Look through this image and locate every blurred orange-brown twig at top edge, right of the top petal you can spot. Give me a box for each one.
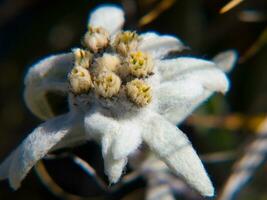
[138,0,176,26]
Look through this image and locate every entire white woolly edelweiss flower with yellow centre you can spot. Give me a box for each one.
[0,6,239,196]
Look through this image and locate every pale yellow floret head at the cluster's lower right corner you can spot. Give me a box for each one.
[126,79,152,107]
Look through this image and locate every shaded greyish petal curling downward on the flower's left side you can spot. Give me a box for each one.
[24,53,74,119]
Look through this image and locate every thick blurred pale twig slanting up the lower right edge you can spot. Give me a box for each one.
[219,118,267,200]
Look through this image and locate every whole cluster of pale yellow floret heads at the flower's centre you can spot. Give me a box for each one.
[68,27,153,107]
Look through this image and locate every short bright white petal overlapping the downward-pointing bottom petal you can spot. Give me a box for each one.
[112,121,142,159]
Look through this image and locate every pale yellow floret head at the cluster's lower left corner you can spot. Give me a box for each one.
[68,66,93,94]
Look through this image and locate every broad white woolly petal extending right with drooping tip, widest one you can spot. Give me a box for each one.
[155,58,229,124]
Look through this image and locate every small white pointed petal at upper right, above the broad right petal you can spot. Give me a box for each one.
[139,32,185,59]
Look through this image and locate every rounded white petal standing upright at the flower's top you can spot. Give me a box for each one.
[88,5,124,35]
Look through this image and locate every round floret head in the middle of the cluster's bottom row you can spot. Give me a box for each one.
[94,71,121,98]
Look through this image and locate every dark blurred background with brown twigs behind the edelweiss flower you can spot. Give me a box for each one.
[0,0,267,200]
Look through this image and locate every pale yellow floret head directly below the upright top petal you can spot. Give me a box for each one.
[83,27,109,53]
